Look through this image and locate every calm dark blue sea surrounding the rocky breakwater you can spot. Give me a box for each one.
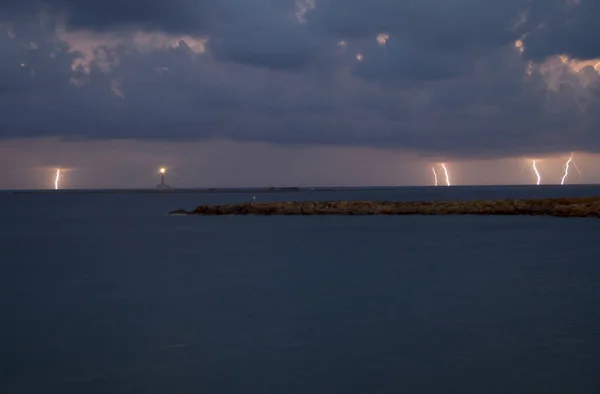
[0,185,600,394]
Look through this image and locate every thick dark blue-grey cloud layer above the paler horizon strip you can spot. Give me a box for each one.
[0,0,600,158]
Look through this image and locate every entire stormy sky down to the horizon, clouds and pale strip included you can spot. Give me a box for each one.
[0,0,600,188]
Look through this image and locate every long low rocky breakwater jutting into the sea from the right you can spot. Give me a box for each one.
[170,197,600,218]
